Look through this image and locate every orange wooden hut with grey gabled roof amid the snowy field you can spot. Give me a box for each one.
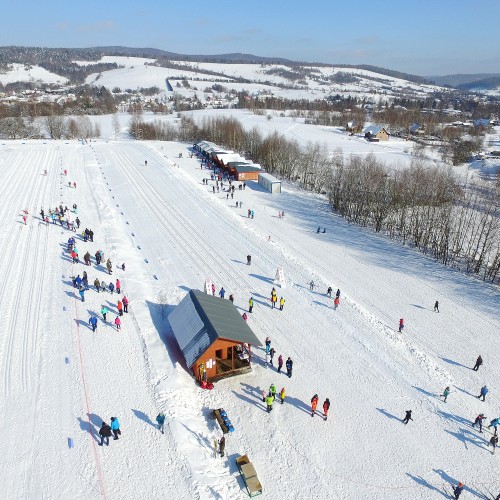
[168,290,262,385]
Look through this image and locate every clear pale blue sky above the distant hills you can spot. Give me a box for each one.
[0,0,500,75]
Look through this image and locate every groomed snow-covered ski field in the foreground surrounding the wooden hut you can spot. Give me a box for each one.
[0,138,500,500]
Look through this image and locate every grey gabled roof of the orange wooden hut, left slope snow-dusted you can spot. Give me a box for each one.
[168,290,262,368]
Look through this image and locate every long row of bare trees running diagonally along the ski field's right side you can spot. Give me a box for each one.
[130,116,500,282]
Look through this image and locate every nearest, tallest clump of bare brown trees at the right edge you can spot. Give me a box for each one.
[328,154,500,282]
